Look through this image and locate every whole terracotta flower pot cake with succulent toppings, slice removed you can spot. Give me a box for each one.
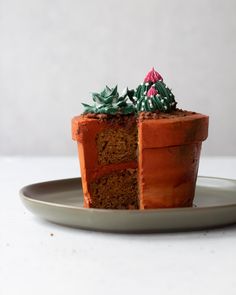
[72,69,208,209]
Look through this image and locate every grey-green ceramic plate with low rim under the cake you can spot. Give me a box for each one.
[20,177,236,232]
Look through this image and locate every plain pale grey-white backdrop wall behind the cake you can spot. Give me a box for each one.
[0,0,236,155]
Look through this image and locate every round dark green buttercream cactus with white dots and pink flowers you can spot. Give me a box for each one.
[134,68,177,113]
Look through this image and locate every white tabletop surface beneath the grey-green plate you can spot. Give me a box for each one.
[0,157,236,295]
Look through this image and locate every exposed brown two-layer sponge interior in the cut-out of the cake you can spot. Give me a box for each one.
[82,114,138,209]
